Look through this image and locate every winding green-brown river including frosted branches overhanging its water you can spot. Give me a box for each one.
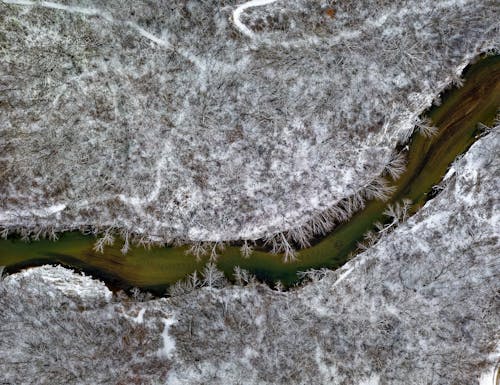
[0,56,500,294]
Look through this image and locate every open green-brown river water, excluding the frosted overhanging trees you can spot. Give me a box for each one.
[0,55,500,294]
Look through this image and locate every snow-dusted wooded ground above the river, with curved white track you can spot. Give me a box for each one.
[0,0,498,241]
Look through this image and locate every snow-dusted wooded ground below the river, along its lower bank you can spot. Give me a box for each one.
[0,127,500,385]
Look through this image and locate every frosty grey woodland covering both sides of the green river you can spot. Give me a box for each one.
[0,0,500,385]
